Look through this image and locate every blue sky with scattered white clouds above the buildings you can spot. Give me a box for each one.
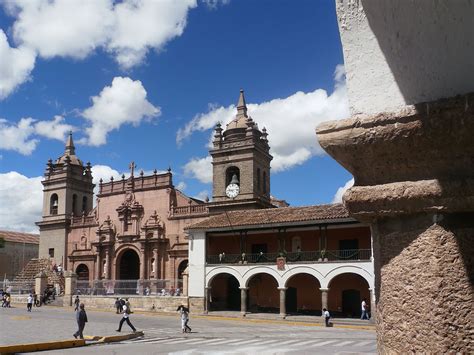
[0,0,353,232]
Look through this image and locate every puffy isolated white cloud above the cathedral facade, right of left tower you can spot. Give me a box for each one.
[82,77,160,146]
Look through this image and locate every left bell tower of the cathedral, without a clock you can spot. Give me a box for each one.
[36,132,95,268]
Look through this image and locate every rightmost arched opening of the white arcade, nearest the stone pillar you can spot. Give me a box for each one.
[328,273,370,318]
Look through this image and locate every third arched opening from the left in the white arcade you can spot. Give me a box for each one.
[285,273,322,315]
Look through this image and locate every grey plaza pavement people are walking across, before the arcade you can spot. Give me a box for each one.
[0,305,376,354]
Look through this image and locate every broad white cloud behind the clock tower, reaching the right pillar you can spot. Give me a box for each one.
[176,65,349,175]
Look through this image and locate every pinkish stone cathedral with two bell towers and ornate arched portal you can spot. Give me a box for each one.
[37,90,278,289]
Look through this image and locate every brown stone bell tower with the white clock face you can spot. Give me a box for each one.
[209,90,273,213]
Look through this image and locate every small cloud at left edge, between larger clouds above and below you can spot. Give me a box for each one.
[0,117,39,155]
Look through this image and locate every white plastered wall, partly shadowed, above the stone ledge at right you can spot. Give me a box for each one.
[336,0,474,114]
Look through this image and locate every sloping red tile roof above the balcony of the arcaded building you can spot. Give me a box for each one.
[185,203,355,230]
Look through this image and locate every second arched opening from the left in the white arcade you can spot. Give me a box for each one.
[247,273,280,313]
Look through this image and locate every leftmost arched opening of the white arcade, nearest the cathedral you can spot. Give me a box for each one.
[209,273,240,311]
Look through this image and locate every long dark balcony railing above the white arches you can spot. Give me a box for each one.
[206,249,372,265]
